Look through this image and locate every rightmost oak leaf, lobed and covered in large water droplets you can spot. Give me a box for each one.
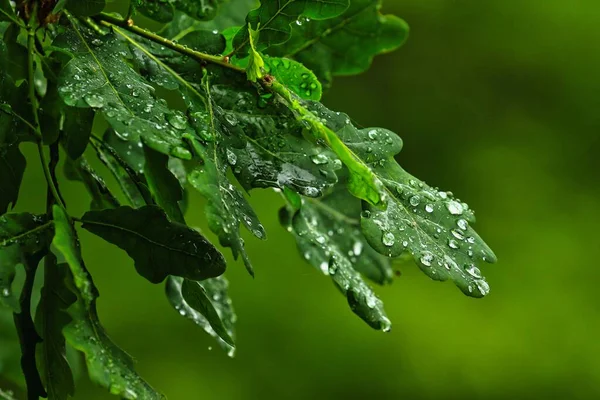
[310,103,496,297]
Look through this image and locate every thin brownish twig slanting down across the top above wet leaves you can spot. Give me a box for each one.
[96,13,246,73]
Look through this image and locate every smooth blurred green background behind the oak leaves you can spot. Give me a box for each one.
[0,0,600,400]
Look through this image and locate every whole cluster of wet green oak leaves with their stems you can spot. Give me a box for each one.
[0,0,495,399]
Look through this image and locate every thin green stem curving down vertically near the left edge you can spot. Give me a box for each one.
[27,22,65,208]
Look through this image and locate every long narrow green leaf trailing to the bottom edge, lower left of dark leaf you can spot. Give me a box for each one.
[52,206,164,400]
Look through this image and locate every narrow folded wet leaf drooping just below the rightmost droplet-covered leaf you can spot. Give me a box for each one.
[280,192,392,332]
